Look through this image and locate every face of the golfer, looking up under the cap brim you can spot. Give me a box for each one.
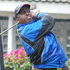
[16,8,32,24]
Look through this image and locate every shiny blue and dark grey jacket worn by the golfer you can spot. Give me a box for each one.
[17,13,67,68]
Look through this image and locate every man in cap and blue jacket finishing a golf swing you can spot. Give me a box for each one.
[15,4,67,70]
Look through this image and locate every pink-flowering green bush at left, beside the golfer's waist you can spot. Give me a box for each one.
[3,48,31,70]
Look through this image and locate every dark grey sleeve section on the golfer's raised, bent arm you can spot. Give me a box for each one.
[35,15,55,41]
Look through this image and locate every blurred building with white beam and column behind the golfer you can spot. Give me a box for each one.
[0,0,70,68]
